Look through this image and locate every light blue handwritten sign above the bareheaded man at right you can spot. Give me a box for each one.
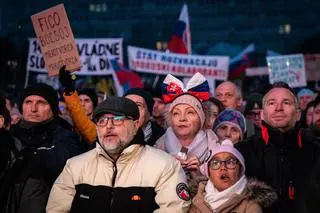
[267,54,307,87]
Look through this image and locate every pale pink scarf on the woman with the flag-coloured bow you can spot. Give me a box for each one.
[164,127,208,162]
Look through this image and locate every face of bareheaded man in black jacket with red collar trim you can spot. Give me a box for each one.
[262,88,301,132]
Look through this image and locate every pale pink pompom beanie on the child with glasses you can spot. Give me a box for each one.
[200,139,246,178]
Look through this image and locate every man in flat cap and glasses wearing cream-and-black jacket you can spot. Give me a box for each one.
[47,97,190,213]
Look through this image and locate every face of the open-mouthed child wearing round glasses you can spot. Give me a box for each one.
[208,152,241,192]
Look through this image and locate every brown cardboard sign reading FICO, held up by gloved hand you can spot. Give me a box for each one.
[31,4,81,76]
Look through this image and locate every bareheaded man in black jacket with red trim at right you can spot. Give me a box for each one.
[237,82,319,213]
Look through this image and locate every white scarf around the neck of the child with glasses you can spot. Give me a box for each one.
[204,175,248,211]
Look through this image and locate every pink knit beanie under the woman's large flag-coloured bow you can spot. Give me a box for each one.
[169,93,205,127]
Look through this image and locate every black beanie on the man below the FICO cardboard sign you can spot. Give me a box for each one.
[19,83,60,116]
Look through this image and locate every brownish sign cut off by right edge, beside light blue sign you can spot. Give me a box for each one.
[304,54,320,81]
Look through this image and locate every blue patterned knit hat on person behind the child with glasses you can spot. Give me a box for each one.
[212,108,247,140]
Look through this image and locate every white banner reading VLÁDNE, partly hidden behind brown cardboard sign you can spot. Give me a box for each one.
[27,38,123,75]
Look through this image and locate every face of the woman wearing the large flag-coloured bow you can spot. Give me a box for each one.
[170,104,201,139]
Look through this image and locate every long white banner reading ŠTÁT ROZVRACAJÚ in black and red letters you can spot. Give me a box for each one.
[128,46,229,80]
